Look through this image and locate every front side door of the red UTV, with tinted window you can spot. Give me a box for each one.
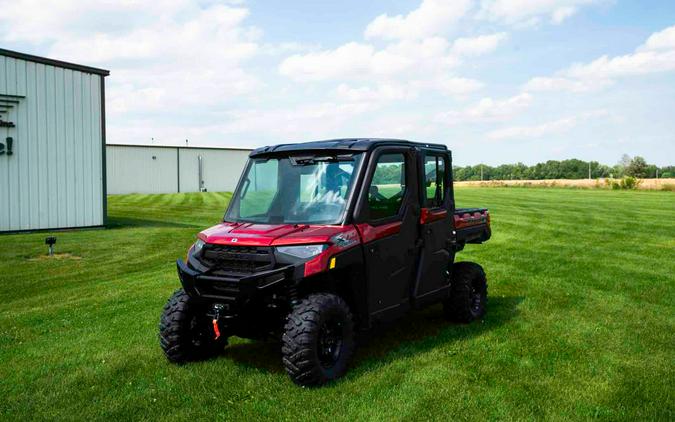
[355,147,419,320]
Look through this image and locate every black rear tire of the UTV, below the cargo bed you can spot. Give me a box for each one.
[443,262,487,323]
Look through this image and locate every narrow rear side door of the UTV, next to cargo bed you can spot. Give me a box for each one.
[412,150,453,305]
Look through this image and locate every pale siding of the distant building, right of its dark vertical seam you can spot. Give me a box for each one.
[180,148,250,192]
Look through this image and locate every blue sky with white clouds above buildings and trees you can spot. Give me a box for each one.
[0,0,675,166]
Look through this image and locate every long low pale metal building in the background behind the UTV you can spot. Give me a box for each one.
[106,144,251,194]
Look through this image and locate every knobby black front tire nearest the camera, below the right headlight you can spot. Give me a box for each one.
[281,293,354,386]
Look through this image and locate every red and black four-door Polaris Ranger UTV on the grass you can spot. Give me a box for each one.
[159,139,490,386]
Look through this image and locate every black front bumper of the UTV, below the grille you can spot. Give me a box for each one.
[176,259,297,303]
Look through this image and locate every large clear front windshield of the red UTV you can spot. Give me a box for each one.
[225,153,362,224]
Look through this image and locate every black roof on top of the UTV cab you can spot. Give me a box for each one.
[251,138,447,157]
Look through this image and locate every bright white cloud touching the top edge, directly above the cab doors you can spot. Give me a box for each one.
[365,0,472,40]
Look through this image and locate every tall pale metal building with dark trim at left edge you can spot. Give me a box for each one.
[0,49,109,232]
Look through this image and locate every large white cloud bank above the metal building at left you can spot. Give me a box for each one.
[0,0,262,119]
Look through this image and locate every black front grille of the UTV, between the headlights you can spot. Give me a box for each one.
[199,245,274,274]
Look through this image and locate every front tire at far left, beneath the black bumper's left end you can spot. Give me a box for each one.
[159,289,227,363]
